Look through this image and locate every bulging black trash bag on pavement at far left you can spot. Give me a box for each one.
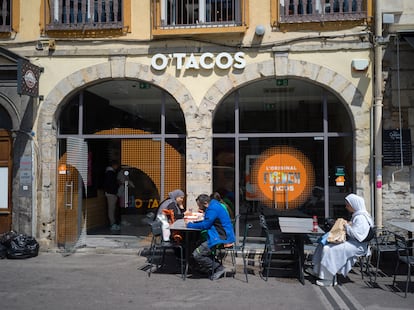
[7,234,39,259]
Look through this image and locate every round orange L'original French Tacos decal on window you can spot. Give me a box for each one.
[249,146,315,209]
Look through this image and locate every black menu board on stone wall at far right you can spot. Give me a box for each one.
[382,129,412,166]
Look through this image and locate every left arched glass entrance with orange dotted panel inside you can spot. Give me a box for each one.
[57,80,186,246]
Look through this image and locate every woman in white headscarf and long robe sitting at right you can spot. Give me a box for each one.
[306,194,374,286]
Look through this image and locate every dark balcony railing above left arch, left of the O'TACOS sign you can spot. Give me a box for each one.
[45,0,123,30]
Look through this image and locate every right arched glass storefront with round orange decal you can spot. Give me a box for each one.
[213,78,354,234]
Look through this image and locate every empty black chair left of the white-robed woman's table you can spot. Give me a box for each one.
[259,215,302,281]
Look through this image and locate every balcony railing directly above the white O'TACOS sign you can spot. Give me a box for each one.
[152,0,246,29]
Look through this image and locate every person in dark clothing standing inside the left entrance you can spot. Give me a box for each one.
[104,160,121,231]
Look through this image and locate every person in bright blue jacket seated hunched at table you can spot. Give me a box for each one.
[187,194,235,280]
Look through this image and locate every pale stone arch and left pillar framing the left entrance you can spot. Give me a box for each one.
[36,56,196,246]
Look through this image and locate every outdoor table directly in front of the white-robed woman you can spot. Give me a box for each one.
[279,217,325,284]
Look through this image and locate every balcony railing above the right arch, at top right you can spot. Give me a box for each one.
[275,0,367,23]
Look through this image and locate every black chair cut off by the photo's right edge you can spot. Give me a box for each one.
[392,234,414,297]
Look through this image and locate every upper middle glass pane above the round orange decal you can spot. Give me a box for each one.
[239,79,323,133]
